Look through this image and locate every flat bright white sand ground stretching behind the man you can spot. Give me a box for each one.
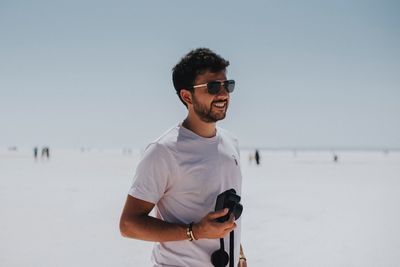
[0,149,400,267]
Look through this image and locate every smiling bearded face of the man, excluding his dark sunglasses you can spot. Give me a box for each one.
[192,71,229,122]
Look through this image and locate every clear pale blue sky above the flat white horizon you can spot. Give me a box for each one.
[0,0,400,149]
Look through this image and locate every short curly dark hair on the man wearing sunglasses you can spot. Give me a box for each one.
[172,48,229,106]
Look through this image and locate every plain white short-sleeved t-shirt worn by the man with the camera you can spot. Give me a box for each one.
[129,125,242,267]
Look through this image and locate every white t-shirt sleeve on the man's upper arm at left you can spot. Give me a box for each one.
[128,143,171,204]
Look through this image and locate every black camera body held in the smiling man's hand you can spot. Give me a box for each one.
[215,188,243,222]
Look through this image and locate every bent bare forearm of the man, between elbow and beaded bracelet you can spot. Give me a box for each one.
[120,215,187,242]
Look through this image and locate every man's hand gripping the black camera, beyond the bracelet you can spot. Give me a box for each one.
[192,209,236,239]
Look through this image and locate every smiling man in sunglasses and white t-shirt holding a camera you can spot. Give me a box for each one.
[120,48,246,267]
